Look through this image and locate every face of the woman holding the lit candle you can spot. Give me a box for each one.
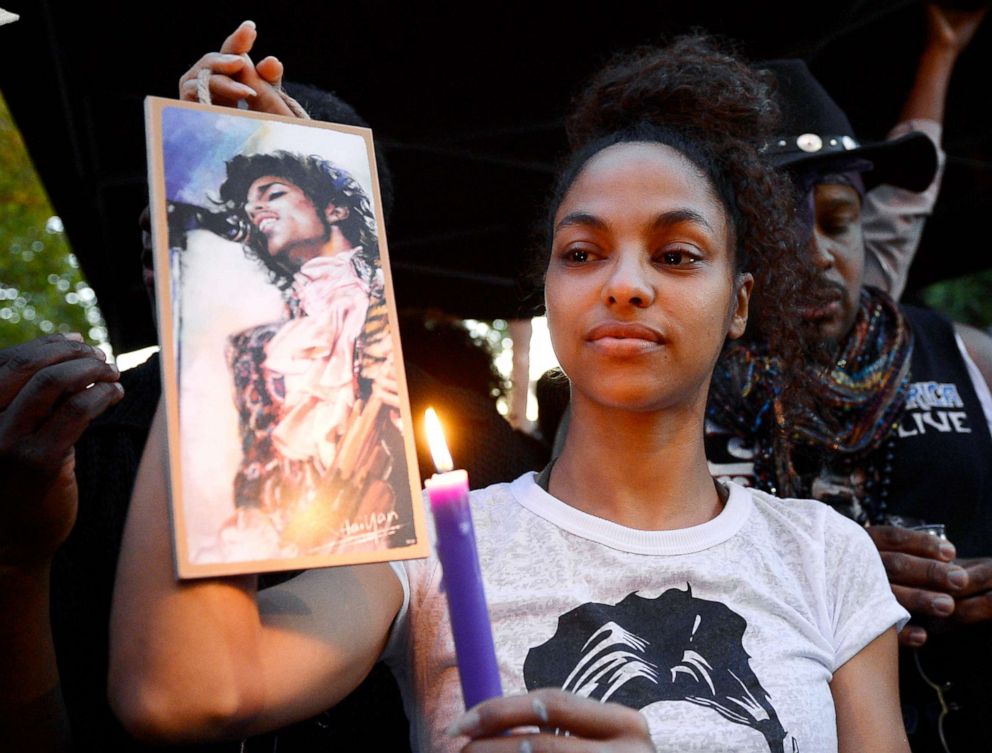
[545,143,751,410]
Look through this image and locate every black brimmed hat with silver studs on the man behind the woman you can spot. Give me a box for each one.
[761,60,937,191]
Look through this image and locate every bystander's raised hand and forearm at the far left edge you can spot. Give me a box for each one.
[0,335,124,751]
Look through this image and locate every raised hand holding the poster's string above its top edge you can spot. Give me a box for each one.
[179,21,293,115]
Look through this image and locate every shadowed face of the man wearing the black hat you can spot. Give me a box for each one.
[806,183,865,342]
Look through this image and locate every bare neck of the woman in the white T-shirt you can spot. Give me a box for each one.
[549,396,724,530]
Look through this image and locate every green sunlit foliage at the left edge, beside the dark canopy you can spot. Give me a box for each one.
[0,89,109,350]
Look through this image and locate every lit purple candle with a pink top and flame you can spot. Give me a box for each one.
[425,408,503,709]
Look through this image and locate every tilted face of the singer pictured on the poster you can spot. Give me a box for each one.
[245,175,328,263]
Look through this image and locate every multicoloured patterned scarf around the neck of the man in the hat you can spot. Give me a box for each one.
[707,288,913,496]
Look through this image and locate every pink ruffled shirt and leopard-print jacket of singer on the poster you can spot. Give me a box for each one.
[229,249,369,507]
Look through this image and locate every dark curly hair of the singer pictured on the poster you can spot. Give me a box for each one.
[217,151,379,288]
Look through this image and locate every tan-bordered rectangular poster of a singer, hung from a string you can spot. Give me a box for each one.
[146,98,427,577]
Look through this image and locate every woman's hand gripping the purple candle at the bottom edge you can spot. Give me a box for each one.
[448,688,655,753]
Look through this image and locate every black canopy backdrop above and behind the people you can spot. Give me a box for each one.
[0,0,992,352]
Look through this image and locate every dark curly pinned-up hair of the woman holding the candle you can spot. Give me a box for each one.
[542,34,822,424]
